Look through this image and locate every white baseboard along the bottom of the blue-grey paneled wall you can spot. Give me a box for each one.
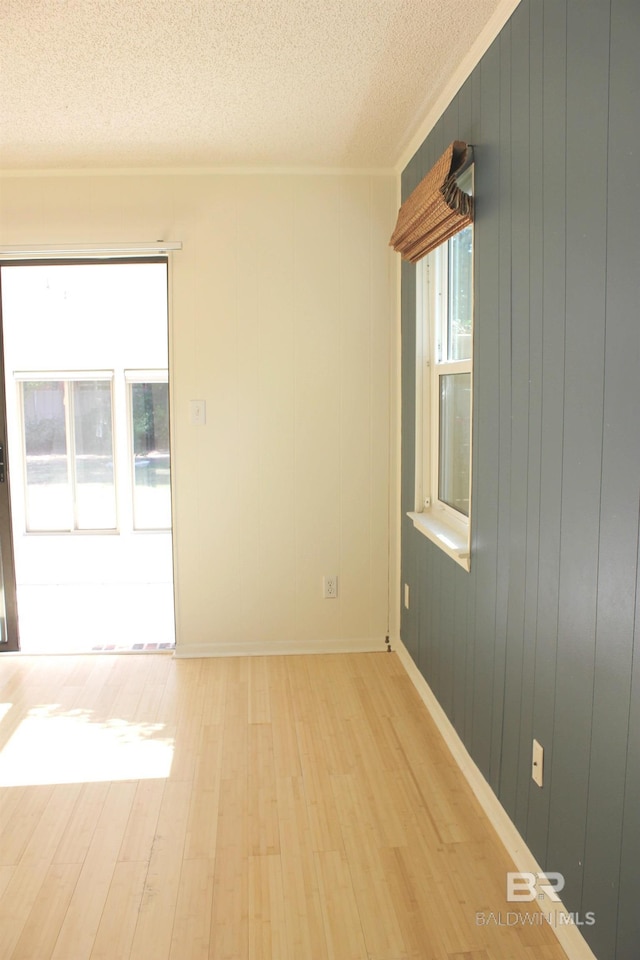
[392,640,597,960]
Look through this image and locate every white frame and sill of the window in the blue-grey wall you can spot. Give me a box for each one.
[409,164,476,571]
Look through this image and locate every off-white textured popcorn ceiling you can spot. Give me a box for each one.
[0,0,504,169]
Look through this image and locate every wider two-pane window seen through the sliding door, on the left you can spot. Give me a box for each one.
[20,373,117,531]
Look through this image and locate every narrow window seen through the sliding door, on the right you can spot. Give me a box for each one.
[126,370,171,530]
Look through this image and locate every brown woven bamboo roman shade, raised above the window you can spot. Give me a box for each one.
[389,140,473,263]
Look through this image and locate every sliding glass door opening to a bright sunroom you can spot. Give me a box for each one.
[0,258,175,654]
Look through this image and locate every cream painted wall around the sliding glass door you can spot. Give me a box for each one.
[0,174,397,656]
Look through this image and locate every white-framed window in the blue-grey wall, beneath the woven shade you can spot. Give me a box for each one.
[410,167,473,570]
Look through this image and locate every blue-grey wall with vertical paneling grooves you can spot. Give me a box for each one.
[402,0,640,960]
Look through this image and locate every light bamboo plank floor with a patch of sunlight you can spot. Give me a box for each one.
[0,653,565,960]
